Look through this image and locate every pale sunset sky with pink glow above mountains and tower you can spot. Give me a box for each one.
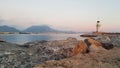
[0,0,120,32]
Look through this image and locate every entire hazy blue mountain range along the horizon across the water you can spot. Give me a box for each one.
[0,25,75,33]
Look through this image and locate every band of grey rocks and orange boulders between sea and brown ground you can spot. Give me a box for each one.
[0,37,117,68]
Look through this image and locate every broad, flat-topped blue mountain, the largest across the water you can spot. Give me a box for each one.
[24,25,58,32]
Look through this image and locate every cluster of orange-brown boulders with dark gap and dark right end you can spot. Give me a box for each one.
[73,38,114,55]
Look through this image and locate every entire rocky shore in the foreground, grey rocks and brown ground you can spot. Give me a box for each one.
[0,35,120,68]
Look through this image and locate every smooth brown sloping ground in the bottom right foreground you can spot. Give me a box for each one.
[34,48,120,68]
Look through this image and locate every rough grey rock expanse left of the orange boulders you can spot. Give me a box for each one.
[0,38,78,68]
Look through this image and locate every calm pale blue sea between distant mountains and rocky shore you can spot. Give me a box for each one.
[0,33,83,44]
